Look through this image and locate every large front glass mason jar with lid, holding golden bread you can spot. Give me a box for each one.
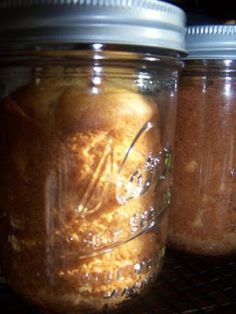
[0,0,184,313]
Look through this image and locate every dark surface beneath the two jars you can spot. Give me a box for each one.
[0,251,236,314]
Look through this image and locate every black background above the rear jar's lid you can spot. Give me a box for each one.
[165,0,236,25]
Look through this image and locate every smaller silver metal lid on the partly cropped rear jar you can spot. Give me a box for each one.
[186,25,236,59]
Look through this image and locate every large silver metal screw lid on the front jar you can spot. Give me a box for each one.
[0,0,185,52]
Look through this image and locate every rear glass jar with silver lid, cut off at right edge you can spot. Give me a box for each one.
[169,25,236,255]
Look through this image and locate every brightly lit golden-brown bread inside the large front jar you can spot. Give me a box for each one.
[1,73,166,311]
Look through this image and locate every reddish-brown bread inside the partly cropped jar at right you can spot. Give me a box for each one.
[169,75,236,256]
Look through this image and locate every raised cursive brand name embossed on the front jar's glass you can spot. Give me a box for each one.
[76,121,162,217]
